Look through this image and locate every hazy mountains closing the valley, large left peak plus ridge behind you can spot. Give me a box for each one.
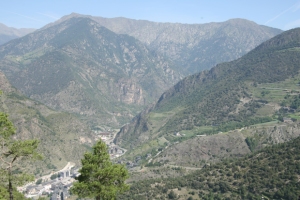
[0,14,281,127]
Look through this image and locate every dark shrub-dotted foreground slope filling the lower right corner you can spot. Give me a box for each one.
[120,134,300,200]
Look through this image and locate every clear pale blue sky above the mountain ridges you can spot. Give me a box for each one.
[0,0,300,30]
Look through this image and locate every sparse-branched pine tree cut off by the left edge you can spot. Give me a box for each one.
[0,112,42,200]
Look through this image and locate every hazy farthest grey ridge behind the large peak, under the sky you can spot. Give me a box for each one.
[48,13,282,75]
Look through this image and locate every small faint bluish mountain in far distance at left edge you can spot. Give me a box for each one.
[0,23,35,45]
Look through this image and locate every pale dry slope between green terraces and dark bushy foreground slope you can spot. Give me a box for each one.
[151,120,300,168]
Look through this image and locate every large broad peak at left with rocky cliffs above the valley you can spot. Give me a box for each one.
[0,18,181,126]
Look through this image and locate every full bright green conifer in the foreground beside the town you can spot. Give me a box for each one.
[71,140,129,200]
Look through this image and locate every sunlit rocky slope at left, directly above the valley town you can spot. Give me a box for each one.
[0,71,95,177]
